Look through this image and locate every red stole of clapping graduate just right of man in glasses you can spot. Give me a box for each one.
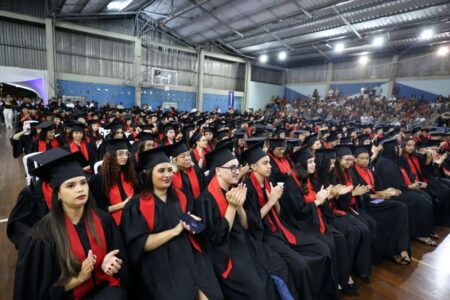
[249,172,297,245]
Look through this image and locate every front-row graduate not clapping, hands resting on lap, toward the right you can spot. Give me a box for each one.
[350,146,411,265]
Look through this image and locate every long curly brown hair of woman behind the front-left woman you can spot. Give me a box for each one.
[101,151,139,194]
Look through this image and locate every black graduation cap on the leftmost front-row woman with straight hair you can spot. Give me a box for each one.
[31,148,89,188]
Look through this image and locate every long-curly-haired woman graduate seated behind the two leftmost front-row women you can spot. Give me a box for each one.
[89,139,139,225]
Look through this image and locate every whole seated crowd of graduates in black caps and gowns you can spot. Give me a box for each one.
[4,92,450,300]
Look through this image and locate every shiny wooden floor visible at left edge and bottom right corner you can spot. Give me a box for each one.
[0,126,450,300]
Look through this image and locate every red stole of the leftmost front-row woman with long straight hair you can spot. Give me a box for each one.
[65,211,120,300]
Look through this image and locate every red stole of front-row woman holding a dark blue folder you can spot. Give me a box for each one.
[139,188,203,253]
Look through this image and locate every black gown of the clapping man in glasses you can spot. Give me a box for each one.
[196,190,290,300]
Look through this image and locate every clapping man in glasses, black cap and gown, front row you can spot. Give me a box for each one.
[197,142,295,300]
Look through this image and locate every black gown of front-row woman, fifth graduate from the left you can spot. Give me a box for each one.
[279,176,350,286]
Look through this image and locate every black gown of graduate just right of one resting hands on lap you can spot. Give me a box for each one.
[375,157,433,238]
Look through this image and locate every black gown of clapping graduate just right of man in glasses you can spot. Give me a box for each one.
[244,179,337,299]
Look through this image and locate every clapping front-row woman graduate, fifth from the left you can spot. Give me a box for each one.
[280,149,357,296]
